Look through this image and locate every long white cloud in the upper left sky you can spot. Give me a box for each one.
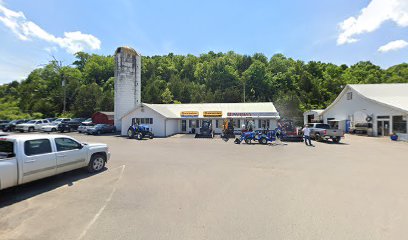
[0,0,101,53]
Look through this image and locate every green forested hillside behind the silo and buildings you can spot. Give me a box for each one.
[0,52,408,119]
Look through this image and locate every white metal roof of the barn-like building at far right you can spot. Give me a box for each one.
[326,83,408,112]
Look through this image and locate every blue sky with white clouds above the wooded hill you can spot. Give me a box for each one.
[0,0,408,84]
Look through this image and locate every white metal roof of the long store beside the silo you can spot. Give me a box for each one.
[125,102,279,118]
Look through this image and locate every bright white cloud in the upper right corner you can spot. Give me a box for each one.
[337,0,408,45]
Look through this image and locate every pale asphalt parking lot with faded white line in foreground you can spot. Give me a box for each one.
[0,133,408,240]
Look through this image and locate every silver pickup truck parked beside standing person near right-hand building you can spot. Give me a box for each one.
[308,123,344,143]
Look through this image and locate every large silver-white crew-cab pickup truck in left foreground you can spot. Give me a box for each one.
[0,134,110,190]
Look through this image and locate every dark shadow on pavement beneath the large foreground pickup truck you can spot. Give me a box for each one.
[0,168,107,208]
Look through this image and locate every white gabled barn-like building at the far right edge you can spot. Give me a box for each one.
[319,83,408,139]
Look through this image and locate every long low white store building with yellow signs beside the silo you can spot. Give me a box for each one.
[120,102,279,137]
